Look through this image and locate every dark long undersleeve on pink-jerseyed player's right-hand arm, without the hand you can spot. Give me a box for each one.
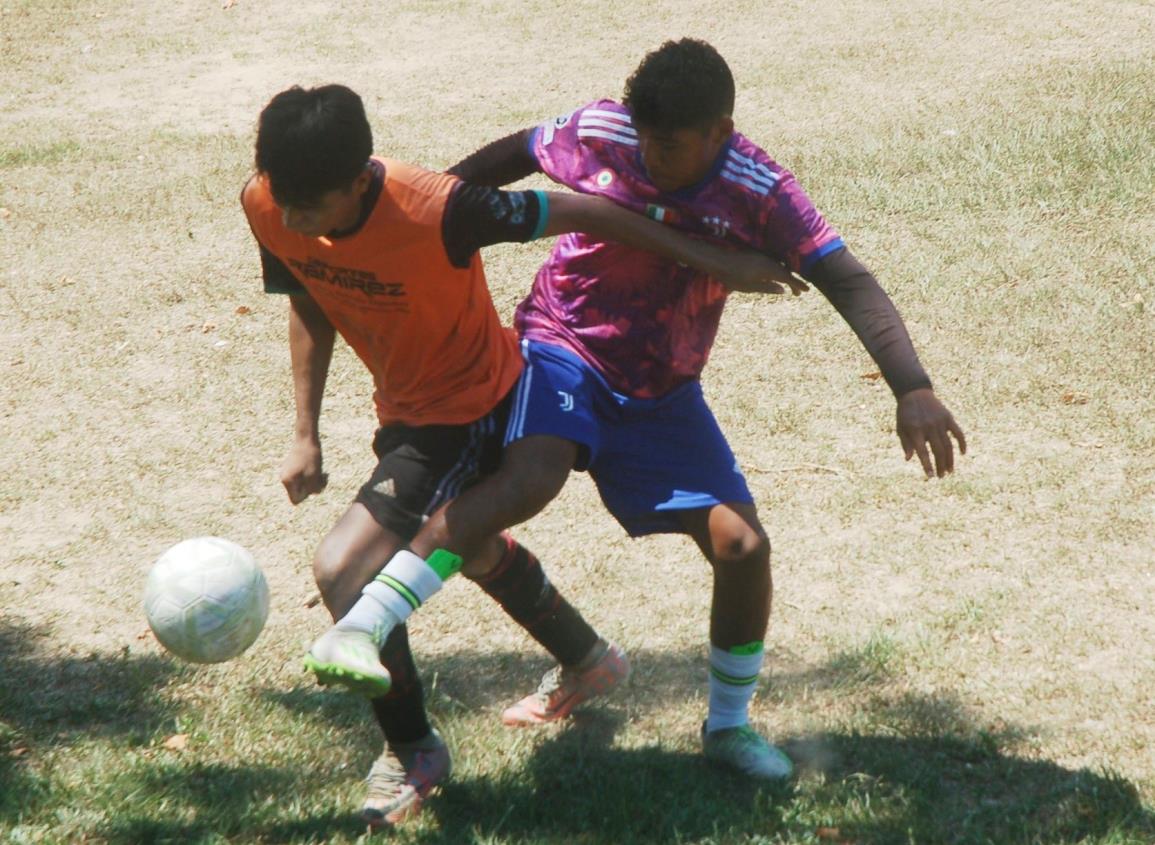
[805,247,931,398]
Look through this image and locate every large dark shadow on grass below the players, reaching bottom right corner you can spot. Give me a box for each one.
[416,711,1155,845]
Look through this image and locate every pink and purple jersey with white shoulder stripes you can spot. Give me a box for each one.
[515,100,842,398]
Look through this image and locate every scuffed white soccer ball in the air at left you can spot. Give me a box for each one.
[144,537,269,663]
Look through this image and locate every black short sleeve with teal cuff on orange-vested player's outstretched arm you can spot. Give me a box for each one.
[441,182,549,268]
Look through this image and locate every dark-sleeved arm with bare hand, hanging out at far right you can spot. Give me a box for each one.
[805,247,967,478]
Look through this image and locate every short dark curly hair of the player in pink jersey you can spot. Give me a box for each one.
[623,38,733,132]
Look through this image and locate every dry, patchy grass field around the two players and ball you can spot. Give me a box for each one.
[0,0,1155,845]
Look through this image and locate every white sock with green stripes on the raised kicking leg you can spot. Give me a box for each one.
[336,549,461,644]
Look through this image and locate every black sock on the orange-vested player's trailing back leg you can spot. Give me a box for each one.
[474,534,598,666]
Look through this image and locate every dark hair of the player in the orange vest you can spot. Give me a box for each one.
[256,85,373,205]
